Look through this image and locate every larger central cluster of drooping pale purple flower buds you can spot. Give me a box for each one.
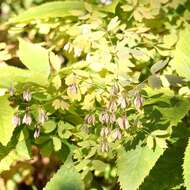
[83,84,143,152]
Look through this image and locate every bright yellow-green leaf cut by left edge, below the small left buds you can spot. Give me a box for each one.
[0,96,15,146]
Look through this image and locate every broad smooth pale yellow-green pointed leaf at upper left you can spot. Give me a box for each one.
[18,39,50,77]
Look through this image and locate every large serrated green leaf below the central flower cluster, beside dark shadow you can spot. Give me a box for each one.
[117,145,164,190]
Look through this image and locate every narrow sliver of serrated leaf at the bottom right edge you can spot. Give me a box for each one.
[183,138,190,190]
